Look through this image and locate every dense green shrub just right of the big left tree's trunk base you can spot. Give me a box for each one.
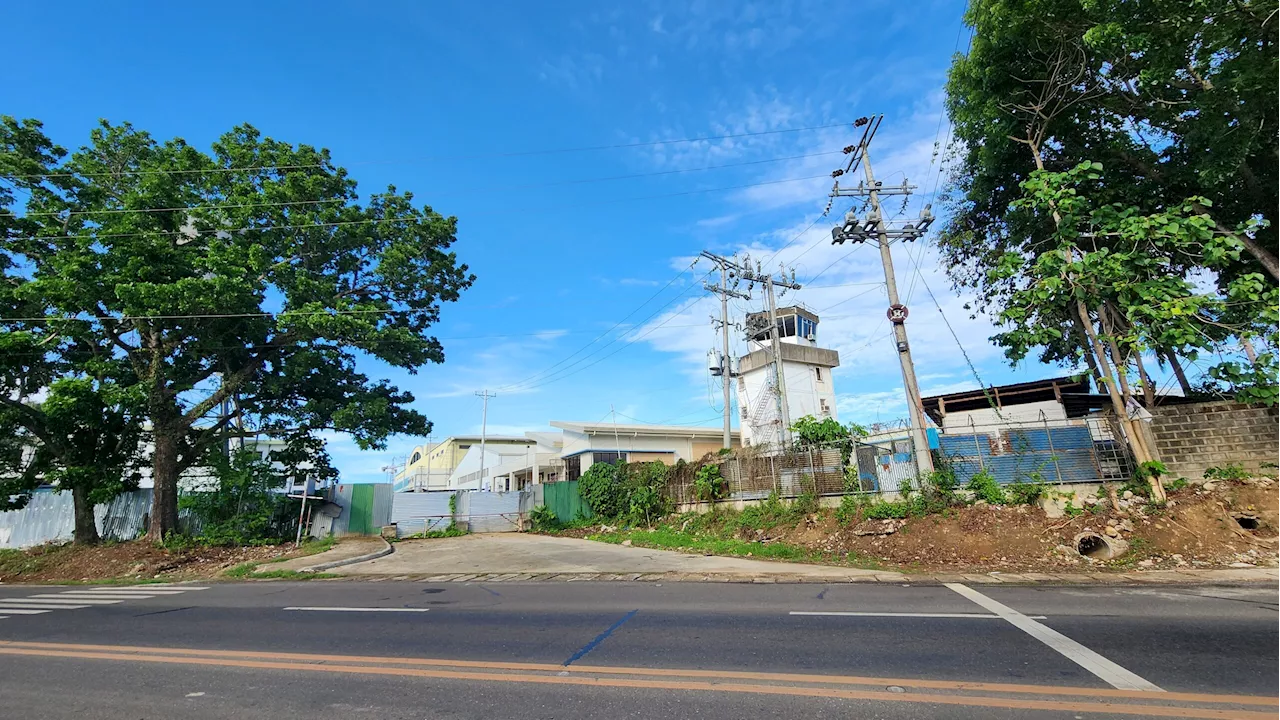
[176,450,300,546]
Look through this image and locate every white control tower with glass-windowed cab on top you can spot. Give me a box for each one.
[737,306,840,445]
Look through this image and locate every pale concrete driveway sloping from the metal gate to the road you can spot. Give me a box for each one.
[332,533,884,579]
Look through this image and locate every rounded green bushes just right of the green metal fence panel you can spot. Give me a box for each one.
[577,461,671,524]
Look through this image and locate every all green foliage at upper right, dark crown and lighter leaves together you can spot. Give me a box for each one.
[938,0,1280,404]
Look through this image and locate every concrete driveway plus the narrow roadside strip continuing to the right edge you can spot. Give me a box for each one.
[332,533,1280,584]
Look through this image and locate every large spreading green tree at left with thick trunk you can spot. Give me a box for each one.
[8,122,475,539]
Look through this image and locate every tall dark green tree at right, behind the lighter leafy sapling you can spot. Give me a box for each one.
[938,0,1280,404]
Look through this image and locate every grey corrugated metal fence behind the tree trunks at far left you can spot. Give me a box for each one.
[0,489,151,548]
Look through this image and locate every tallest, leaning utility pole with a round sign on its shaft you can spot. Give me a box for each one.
[831,115,933,475]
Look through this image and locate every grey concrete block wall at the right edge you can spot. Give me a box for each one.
[1151,400,1280,478]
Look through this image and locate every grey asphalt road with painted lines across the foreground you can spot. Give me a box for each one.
[0,580,1280,720]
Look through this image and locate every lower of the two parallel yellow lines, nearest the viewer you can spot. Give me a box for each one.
[0,643,1280,720]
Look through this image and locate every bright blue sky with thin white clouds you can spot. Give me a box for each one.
[0,0,1100,480]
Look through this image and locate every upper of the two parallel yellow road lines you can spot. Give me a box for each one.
[0,641,1280,710]
